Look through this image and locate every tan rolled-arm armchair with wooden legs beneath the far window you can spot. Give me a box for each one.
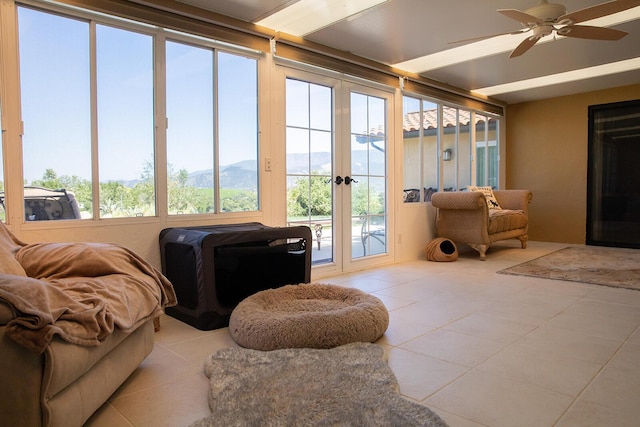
[431,190,532,261]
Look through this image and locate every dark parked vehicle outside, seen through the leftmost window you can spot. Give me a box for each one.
[0,186,81,221]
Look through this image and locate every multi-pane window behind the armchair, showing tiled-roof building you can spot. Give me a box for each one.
[403,96,498,203]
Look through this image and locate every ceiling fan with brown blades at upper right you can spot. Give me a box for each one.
[452,0,640,58]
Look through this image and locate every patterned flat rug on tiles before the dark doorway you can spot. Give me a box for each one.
[498,246,640,290]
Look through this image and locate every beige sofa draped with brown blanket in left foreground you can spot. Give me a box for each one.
[0,223,176,427]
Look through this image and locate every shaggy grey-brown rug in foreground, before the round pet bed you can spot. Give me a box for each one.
[192,343,447,427]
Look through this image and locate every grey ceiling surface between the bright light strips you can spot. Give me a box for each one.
[162,0,640,104]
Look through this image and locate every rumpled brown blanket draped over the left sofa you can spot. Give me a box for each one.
[0,243,176,353]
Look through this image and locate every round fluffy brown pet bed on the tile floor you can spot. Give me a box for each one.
[229,283,389,351]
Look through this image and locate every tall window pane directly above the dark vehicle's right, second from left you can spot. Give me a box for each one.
[96,25,156,218]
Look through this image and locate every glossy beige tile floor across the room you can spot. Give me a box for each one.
[88,241,640,427]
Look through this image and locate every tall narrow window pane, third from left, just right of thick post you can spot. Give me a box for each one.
[166,42,215,215]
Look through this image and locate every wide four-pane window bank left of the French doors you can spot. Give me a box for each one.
[18,6,258,220]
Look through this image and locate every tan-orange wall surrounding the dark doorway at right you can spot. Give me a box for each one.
[506,84,640,244]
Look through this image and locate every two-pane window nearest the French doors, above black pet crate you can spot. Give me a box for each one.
[166,41,258,214]
